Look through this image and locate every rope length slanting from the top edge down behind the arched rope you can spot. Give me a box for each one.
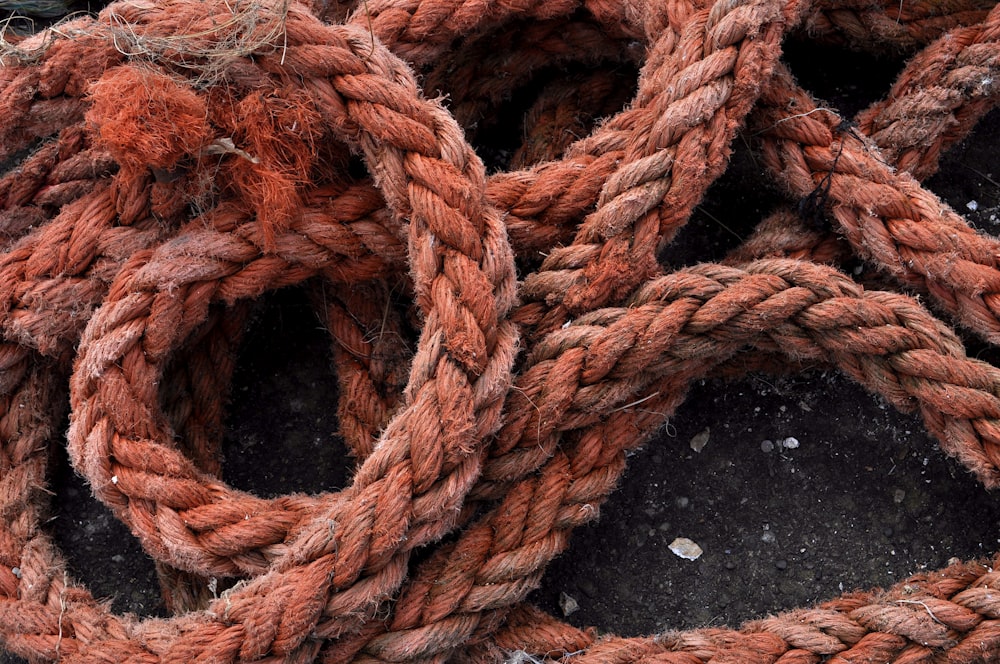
[519,3,795,331]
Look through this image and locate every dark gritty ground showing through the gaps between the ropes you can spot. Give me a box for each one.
[0,20,1000,662]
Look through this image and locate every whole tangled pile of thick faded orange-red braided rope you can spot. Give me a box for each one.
[0,0,1000,664]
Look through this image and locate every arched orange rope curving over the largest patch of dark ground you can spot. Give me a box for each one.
[334,261,1000,661]
